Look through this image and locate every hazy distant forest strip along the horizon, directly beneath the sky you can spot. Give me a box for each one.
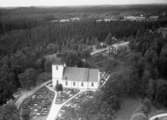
[0,5,167,17]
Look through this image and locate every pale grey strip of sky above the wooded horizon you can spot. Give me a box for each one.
[0,0,167,7]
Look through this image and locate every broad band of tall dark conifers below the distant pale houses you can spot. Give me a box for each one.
[0,22,159,54]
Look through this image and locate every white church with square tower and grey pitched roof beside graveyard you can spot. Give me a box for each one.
[52,63,100,90]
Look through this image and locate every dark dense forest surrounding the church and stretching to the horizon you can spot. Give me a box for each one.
[0,6,167,120]
